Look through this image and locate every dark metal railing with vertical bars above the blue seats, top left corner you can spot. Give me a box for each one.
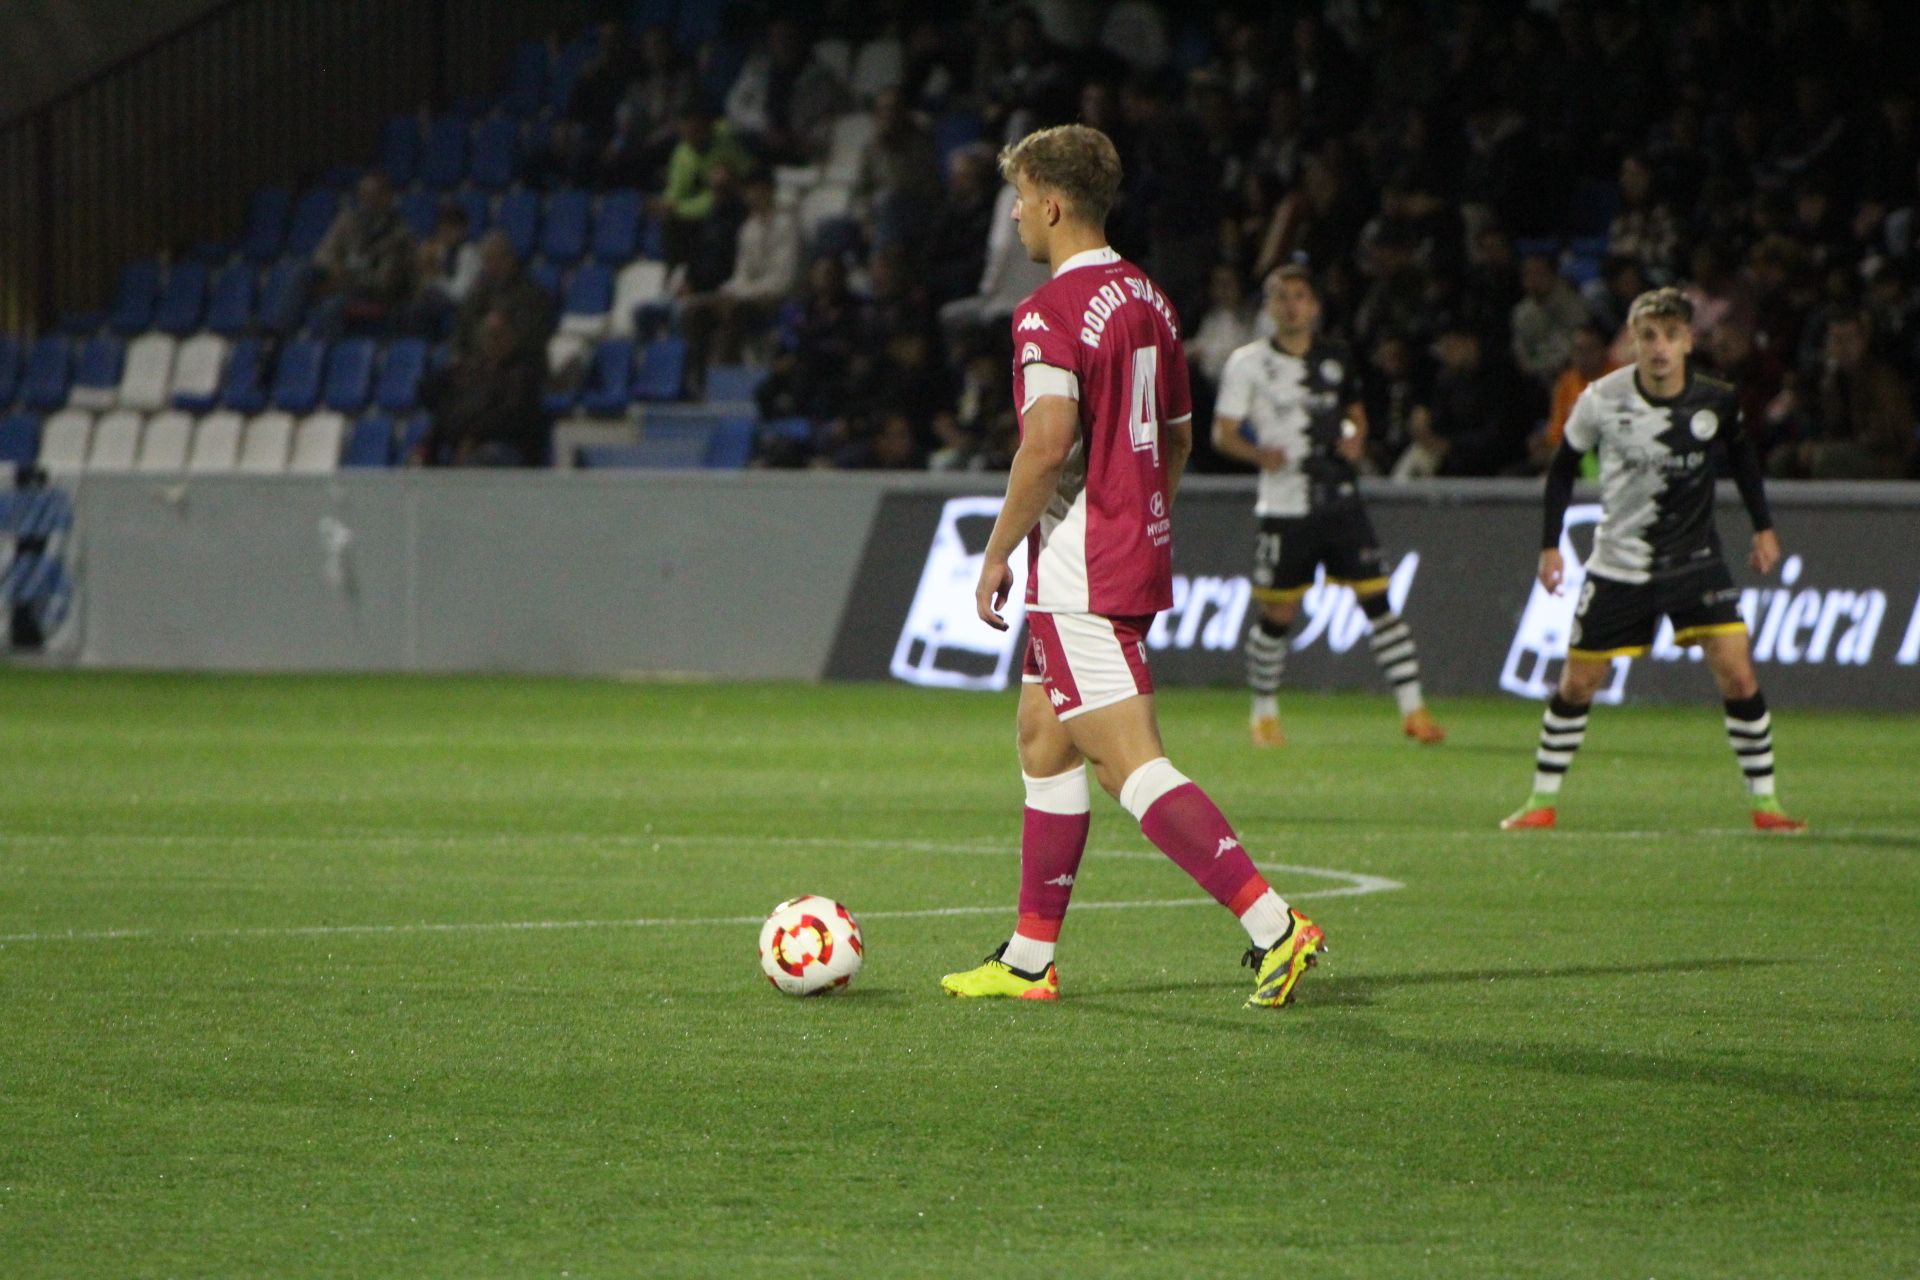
[0,0,588,334]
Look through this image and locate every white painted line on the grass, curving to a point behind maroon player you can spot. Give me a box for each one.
[0,837,1405,946]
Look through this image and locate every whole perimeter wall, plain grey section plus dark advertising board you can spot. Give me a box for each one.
[37,472,1920,708]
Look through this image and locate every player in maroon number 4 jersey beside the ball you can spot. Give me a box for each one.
[941,125,1325,1007]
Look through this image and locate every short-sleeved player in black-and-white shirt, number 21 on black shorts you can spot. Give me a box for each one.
[1213,267,1446,747]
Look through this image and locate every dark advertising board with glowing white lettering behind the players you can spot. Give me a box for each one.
[828,478,1920,706]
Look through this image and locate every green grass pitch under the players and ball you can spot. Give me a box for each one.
[0,670,1920,1276]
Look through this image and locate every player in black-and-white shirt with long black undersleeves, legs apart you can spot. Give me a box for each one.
[1500,288,1807,831]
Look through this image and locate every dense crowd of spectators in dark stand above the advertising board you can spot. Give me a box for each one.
[560,0,1920,478]
